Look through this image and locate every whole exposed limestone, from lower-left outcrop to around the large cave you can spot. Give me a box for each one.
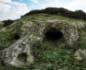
[0,20,85,67]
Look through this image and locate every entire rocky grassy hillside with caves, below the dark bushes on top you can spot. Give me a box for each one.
[0,8,86,70]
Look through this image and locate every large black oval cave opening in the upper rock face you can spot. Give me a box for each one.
[45,27,63,41]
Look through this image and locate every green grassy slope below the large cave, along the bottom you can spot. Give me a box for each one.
[0,39,86,70]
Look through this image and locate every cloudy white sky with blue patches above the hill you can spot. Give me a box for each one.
[0,0,86,20]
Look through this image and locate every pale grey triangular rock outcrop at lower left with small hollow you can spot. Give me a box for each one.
[0,36,34,67]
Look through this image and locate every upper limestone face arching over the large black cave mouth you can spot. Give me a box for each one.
[23,20,79,45]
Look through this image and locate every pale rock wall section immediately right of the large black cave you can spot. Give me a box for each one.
[64,24,79,45]
